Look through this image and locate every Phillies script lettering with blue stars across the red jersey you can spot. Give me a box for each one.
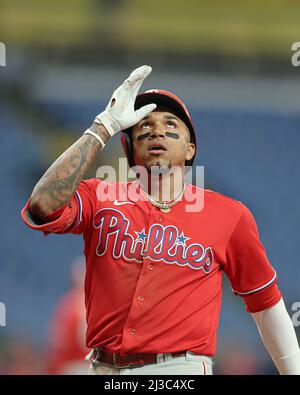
[94,208,213,273]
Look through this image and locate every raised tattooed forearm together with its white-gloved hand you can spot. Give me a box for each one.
[30,66,156,219]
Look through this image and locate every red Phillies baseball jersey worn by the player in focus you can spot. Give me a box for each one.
[22,179,281,356]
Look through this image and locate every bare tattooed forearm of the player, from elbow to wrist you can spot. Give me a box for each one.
[30,123,110,218]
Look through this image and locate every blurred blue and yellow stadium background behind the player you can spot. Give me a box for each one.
[0,0,300,374]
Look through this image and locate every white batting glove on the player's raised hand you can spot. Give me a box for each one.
[94,66,157,136]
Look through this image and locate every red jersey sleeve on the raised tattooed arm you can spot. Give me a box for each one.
[21,179,99,236]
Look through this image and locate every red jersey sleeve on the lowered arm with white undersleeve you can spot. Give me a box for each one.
[224,204,279,312]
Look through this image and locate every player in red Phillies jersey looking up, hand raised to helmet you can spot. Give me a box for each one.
[22,66,300,375]
